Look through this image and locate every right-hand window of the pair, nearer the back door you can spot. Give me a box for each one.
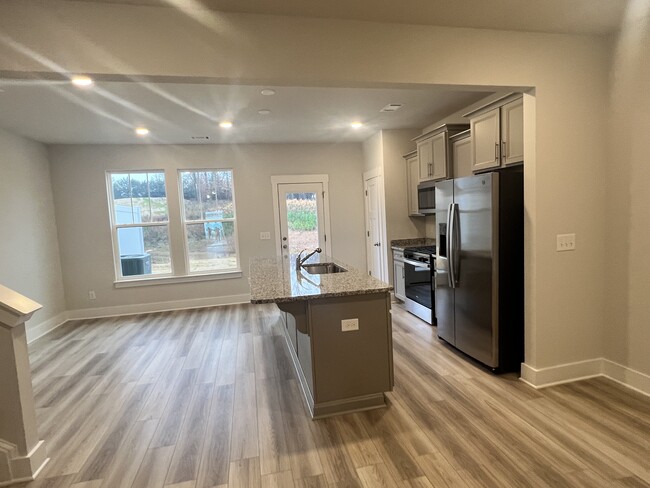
[180,170,239,273]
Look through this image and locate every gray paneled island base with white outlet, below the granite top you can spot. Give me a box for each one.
[277,292,393,419]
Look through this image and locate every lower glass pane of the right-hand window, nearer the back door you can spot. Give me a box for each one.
[187,222,237,273]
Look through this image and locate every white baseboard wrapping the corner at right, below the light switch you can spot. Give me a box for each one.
[520,358,650,395]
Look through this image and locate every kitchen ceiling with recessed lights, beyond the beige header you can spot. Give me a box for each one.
[0,79,491,144]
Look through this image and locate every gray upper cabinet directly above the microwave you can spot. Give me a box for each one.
[413,124,468,181]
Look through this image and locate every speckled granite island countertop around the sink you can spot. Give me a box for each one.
[248,254,393,303]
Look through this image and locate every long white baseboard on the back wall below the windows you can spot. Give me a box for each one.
[68,293,250,320]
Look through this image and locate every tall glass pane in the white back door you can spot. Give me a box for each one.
[286,192,319,254]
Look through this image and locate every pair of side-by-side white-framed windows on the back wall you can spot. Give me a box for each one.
[107,169,241,287]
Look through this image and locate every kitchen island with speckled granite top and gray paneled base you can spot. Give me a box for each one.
[249,254,393,418]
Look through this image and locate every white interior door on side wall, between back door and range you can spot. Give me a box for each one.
[364,176,388,281]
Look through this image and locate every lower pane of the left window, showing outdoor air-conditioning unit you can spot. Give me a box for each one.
[117,225,172,276]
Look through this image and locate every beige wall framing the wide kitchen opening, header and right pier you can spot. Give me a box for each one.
[0,0,616,368]
